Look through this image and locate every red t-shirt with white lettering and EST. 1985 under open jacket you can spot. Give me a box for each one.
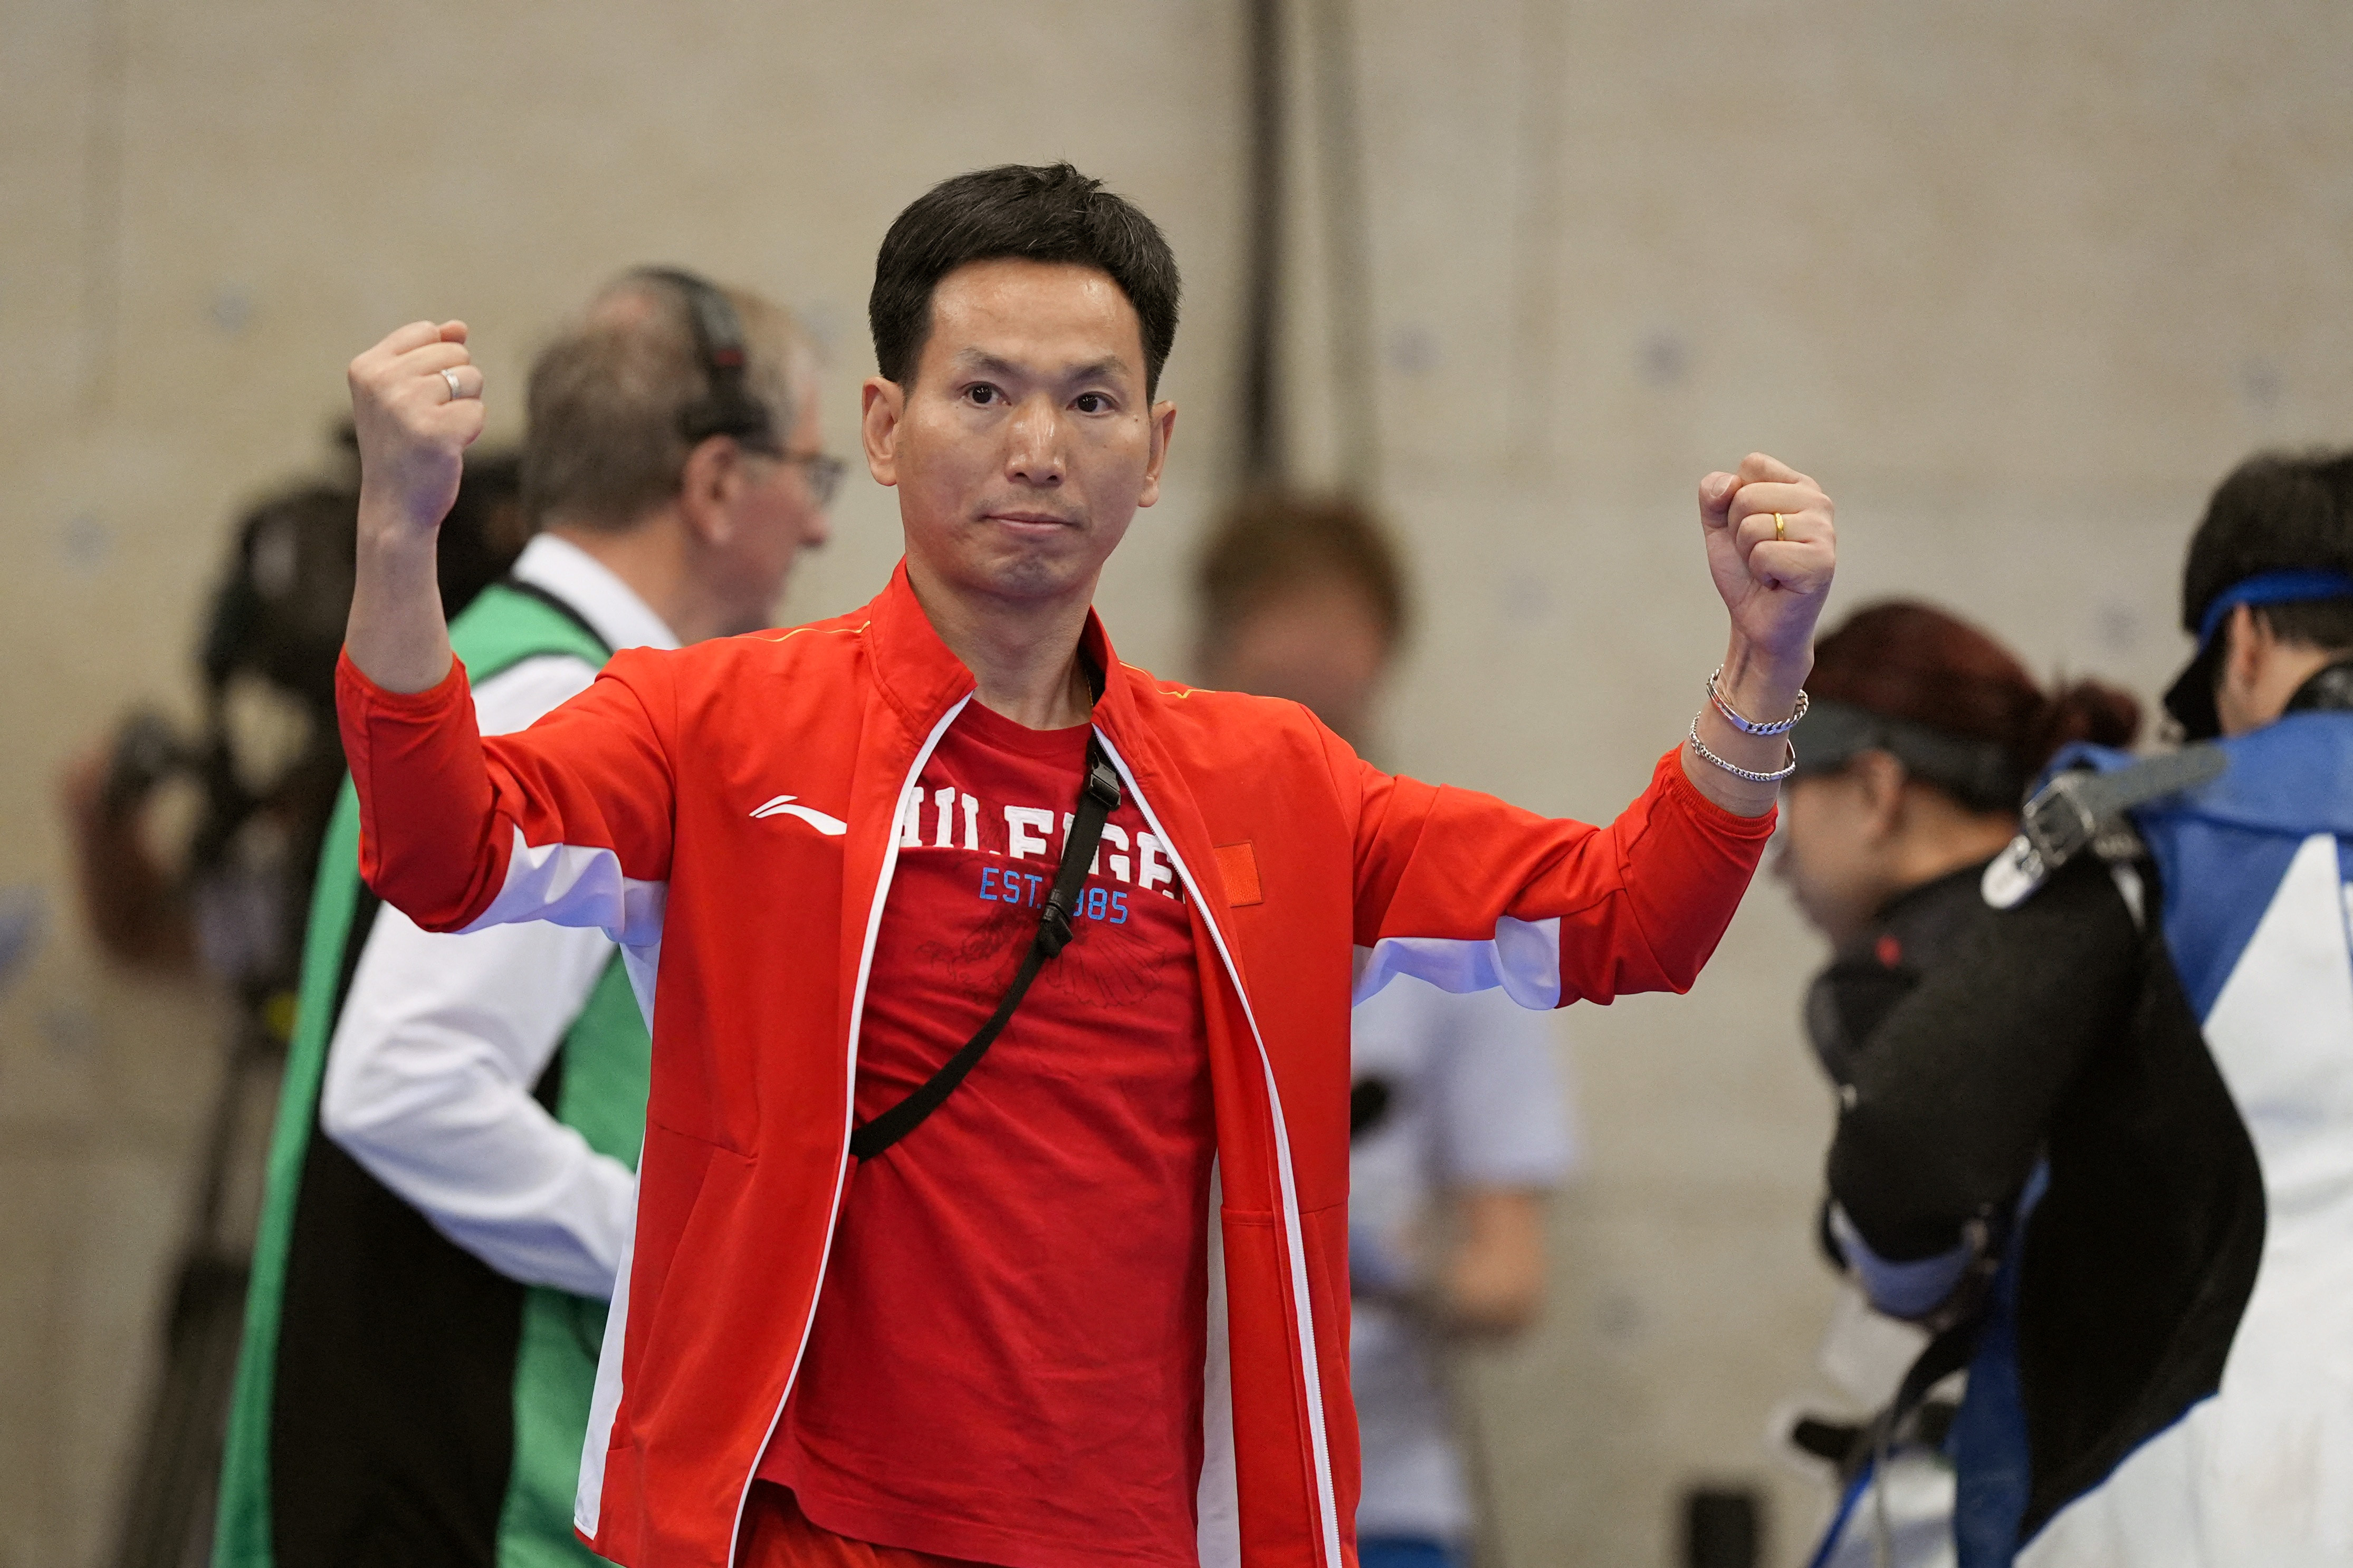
[760,703,1214,1568]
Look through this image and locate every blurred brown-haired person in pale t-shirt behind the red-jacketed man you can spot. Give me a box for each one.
[1195,492,1579,1568]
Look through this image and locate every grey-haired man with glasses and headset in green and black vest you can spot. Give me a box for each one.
[214,271,843,1568]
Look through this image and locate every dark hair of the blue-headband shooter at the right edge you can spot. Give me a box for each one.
[2181,451,2353,649]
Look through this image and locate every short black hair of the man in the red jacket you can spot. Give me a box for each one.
[866,162,1179,397]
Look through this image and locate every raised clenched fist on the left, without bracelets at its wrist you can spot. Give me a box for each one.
[348,322,482,543]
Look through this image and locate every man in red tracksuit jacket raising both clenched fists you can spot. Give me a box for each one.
[339,167,1833,1568]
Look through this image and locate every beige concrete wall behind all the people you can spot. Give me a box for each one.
[0,0,2353,1568]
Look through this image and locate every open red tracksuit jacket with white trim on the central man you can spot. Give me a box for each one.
[339,566,1772,1568]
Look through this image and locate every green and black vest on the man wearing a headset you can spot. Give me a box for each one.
[212,585,652,1568]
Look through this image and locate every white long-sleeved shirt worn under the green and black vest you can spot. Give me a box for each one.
[318,534,677,1300]
